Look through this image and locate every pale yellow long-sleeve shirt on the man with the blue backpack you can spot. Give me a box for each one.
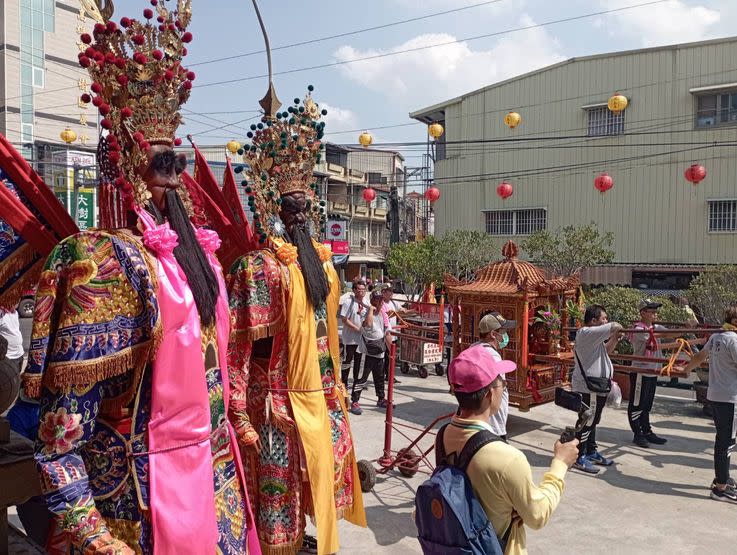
[443,416,568,555]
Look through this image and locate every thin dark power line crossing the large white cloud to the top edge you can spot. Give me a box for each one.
[193,0,669,88]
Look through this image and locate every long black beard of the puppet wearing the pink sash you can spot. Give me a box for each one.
[156,189,220,327]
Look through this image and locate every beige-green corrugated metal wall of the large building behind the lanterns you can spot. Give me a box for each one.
[435,39,737,264]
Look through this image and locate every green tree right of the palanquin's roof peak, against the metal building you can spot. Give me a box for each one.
[520,222,614,276]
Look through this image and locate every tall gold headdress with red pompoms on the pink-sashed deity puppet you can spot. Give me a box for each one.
[79,0,195,206]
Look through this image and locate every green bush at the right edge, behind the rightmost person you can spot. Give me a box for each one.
[687,264,737,325]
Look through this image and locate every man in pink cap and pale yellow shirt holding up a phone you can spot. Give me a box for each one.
[443,345,578,555]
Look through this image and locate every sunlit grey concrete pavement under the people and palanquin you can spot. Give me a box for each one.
[340,375,737,555]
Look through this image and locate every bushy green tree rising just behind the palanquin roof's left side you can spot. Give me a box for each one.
[440,229,499,280]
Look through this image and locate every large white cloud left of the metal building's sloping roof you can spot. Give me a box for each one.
[334,16,563,106]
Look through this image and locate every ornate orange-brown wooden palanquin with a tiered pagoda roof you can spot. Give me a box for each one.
[445,241,580,411]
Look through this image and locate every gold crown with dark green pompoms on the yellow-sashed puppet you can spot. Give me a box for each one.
[236,85,327,243]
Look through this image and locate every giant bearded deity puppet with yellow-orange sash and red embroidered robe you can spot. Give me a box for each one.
[227,6,366,555]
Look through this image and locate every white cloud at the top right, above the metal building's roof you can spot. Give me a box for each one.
[600,0,721,46]
